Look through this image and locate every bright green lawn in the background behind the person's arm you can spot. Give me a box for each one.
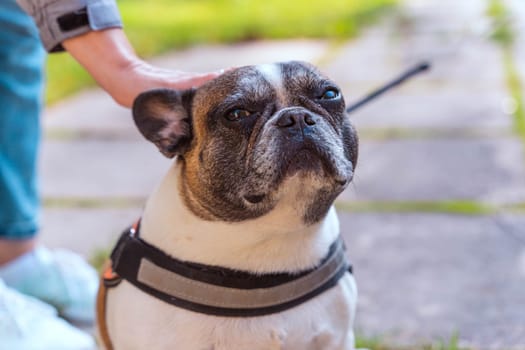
[47,0,398,103]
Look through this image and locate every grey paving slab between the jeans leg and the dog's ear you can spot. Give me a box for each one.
[40,140,171,198]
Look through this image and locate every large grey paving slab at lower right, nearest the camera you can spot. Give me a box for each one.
[340,213,525,350]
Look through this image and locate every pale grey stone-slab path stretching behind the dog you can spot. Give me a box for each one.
[41,0,525,349]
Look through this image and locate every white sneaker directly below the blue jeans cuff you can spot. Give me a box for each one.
[0,247,99,325]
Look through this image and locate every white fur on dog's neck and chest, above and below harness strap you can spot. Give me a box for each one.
[106,166,357,350]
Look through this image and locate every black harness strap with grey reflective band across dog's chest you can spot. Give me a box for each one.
[104,224,352,317]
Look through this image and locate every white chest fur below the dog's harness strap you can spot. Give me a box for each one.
[107,274,357,350]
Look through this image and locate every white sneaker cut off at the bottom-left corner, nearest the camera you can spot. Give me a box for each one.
[0,279,96,350]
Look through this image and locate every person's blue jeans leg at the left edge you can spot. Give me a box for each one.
[0,0,45,239]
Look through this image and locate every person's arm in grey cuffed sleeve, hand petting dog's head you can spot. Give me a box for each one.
[17,0,219,107]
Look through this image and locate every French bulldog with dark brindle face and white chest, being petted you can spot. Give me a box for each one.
[97,62,358,350]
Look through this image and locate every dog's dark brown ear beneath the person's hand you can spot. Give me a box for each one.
[133,89,195,158]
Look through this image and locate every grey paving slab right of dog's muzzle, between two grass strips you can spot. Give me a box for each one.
[340,138,525,203]
